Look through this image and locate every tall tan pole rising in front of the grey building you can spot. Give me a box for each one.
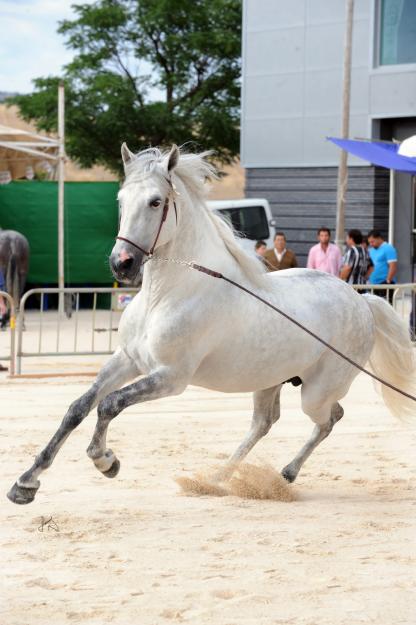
[335,0,354,251]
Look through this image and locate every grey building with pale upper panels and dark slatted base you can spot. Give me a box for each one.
[241,0,416,281]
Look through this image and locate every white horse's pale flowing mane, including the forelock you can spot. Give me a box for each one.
[126,148,265,285]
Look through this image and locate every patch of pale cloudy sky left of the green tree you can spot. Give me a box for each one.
[0,0,93,93]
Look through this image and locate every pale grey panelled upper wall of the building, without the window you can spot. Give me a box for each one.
[241,0,416,168]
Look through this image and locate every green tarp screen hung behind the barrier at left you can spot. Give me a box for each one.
[0,181,119,285]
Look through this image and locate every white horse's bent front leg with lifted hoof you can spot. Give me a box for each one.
[87,367,187,477]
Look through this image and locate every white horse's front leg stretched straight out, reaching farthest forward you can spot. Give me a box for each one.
[7,350,140,504]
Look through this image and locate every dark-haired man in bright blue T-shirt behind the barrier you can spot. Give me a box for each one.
[368,230,397,301]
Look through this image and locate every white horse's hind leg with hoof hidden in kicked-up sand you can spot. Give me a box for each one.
[215,384,282,480]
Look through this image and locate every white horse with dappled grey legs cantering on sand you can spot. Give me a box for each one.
[8,144,415,504]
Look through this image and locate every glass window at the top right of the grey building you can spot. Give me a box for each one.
[380,0,416,65]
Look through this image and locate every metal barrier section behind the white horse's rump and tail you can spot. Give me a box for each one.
[352,282,416,340]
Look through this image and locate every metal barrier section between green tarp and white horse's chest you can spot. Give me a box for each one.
[16,287,138,375]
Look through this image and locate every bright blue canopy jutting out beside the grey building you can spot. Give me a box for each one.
[328,137,416,175]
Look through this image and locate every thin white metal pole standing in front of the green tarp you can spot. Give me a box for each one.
[58,83,65,315]
